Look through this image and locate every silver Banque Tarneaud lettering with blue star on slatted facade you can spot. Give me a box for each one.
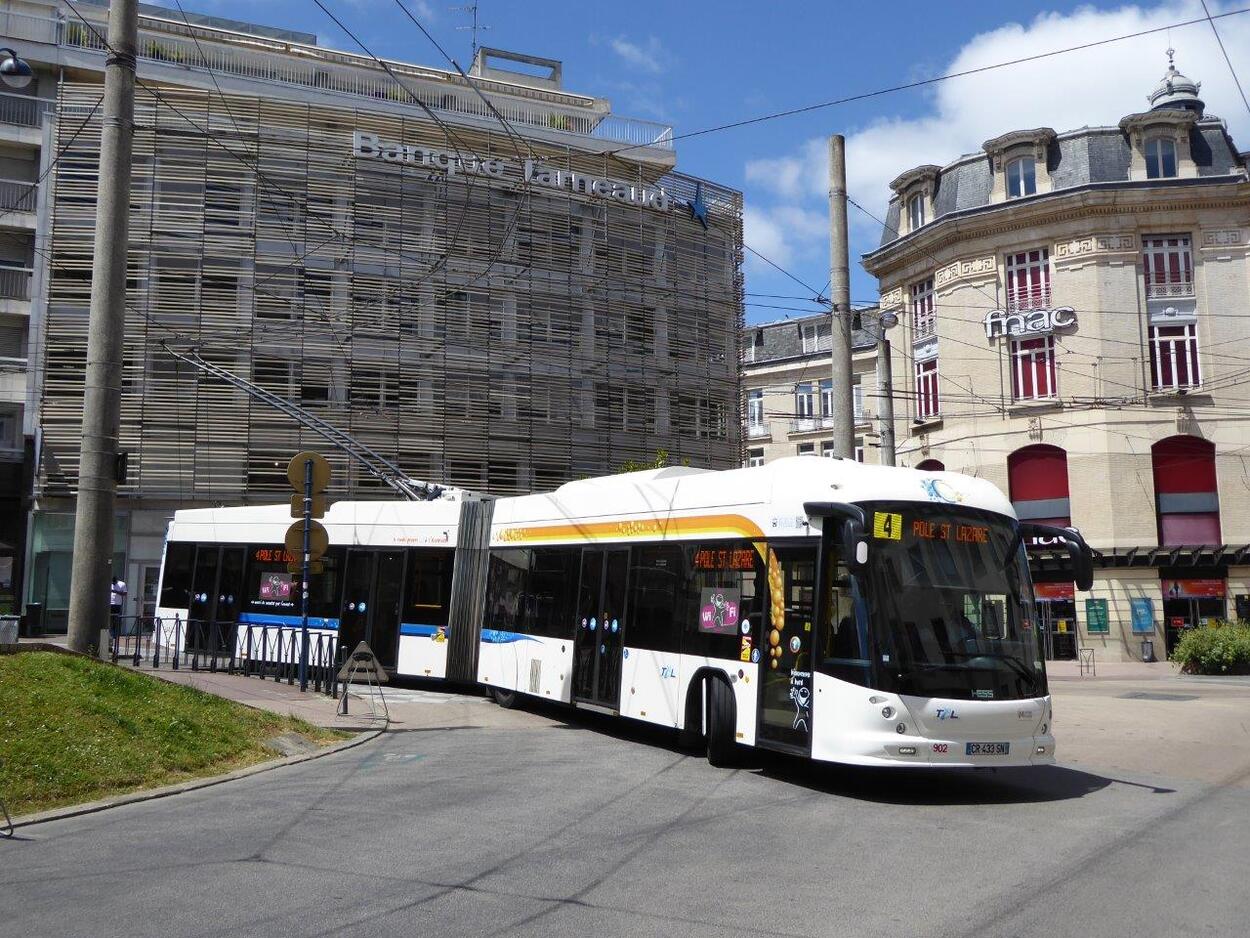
[351,130,708,216]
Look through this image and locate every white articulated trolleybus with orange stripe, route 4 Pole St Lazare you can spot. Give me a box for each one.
[160,456,1091,767]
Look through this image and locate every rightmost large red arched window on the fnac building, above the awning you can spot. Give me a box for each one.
[1150,436,1220,547]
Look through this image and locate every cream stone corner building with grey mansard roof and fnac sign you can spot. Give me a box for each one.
[864,53,1250,660]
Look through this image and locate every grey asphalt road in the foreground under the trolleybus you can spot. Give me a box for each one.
[0,680,1250,938]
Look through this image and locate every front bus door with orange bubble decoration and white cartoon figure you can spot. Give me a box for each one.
[758,544,816,754]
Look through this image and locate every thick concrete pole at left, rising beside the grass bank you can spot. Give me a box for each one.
[69,0,139,652]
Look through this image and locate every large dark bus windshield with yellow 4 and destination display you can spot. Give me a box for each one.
[865,503,1046,700]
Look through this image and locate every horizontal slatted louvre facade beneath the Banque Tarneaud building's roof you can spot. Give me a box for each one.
[39,85,743,507]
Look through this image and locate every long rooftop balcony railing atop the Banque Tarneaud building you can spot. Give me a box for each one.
[61,16,673,150]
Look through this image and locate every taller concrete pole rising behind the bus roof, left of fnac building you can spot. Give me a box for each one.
[829,134,855,459]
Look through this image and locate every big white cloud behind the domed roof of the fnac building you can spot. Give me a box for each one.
[745,0,1250,281]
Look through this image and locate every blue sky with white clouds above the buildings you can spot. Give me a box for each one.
[151,0,1250,321]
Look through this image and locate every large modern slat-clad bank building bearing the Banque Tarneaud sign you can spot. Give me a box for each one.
[5,1,743,628]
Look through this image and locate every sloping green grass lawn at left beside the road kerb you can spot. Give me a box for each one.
[0,652,346,817]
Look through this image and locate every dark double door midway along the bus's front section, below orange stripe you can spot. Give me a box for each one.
[573,548,629,710]
